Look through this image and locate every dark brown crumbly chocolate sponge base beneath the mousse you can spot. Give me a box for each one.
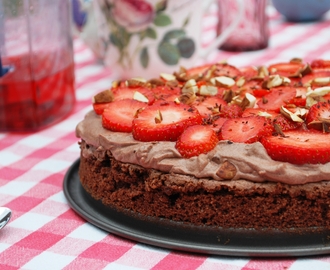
[79,141,330,230]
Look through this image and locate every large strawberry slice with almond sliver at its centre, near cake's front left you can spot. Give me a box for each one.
[132,102,202,142]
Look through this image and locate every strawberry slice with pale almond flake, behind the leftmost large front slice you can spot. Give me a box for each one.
[112,87,155,105]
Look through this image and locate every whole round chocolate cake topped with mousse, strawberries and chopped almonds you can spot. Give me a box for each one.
[76,59,330,230]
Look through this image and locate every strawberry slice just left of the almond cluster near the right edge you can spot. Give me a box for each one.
[257,86,296,112]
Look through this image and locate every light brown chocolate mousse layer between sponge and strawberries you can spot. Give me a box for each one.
[76,111,330,185]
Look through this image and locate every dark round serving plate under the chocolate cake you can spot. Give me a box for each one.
[63,159,330,257]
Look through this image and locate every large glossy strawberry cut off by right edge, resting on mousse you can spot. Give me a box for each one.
[260,130,330,165]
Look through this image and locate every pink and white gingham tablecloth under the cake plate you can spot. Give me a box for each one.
[0,4,330,270]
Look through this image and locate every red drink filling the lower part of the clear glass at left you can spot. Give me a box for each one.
[0,55,75,131]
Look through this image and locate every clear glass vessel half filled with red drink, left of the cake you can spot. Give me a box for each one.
[0,0,75,131]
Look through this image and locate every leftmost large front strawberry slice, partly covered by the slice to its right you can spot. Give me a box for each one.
[102,99,147,132]
